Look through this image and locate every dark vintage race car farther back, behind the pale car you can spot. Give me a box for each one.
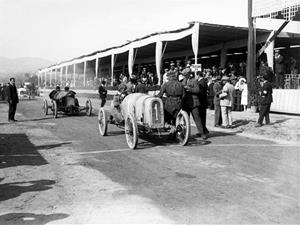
[42,91,92,118]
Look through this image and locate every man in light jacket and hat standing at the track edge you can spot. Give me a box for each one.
[219,76,234,128]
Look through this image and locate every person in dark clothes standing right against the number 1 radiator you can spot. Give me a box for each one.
[157,71,185,139]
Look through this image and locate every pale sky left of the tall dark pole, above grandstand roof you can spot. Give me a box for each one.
[0,0,248,62]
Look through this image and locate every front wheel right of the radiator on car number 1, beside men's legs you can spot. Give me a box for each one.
[176,110,191,146]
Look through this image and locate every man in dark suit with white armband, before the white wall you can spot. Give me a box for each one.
[255,75,273,127]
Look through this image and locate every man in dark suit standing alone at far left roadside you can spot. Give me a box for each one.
[6,77,19,122]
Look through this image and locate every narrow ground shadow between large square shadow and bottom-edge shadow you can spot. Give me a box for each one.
[0,180,55,202]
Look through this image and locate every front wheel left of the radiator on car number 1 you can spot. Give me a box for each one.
[125,114,138,149]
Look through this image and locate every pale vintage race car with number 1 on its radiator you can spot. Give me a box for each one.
[98,93,191,149]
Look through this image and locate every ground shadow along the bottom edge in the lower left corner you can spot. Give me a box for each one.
[0,213,69,225]
